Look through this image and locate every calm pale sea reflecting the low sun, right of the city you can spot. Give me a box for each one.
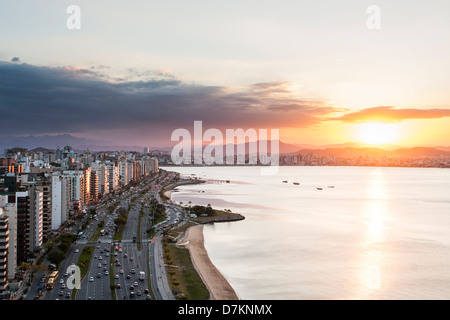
[166,167,450,300]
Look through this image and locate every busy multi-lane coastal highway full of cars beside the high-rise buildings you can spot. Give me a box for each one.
[31,172,184,300]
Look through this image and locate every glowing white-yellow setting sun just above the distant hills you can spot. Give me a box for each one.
[358,122,398,144]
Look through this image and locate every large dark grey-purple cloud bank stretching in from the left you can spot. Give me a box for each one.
[0,62,336,144]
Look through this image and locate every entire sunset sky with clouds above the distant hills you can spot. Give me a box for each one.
[0,0,450,146]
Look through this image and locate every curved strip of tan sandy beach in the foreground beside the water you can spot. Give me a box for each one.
[178,225,239,300]
